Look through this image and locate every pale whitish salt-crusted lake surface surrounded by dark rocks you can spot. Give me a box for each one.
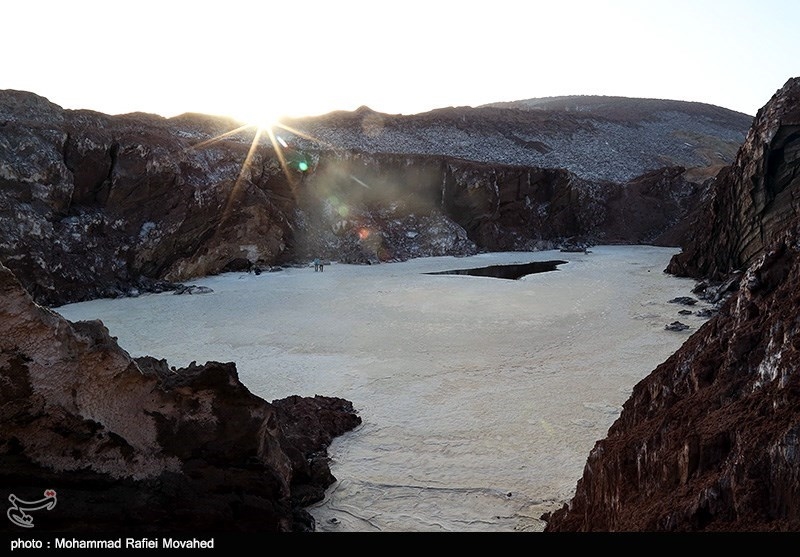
[55,246,704,532]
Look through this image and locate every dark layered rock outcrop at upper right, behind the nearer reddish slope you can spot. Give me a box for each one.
[667,80,800,281]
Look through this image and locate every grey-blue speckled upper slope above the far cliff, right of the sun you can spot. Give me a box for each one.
[286,97,753,182]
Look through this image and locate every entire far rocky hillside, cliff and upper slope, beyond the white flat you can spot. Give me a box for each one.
[0,91,747,305]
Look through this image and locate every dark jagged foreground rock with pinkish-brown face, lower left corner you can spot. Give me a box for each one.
[0,266,361,533]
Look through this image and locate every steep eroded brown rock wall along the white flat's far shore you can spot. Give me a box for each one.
[0,91,708,306]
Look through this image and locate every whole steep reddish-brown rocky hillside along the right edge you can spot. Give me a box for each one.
[546,78,800,532]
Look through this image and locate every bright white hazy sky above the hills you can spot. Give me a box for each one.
[0,0,800,121]
